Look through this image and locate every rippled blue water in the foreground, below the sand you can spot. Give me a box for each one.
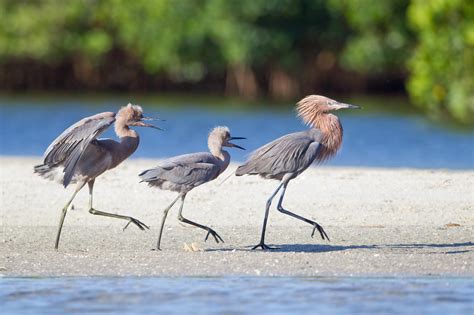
[0,277,474,315]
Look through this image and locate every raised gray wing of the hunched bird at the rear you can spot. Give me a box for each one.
[43,112,115,187]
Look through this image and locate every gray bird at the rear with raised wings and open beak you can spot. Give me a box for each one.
[34,104,160,249]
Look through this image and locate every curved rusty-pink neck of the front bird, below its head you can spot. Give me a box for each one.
[312,113,343,161]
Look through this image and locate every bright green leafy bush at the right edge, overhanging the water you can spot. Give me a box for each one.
[407,0,474,123]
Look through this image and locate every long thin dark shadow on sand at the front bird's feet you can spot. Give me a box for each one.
[206,242,474,254]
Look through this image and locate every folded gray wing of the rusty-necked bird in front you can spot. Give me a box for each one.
[236,133,320,175]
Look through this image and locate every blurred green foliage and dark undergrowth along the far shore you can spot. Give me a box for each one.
[0,0,474,123]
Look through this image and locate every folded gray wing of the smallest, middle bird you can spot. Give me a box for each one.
[139,161,219,187]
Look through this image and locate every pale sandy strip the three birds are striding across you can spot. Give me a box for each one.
[0,157,474,276]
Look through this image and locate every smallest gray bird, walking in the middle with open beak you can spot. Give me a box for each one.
[139,127,245,250]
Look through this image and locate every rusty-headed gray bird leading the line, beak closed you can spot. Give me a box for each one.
[235,95,360,249]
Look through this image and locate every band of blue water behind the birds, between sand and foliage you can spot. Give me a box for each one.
[0,97,474,169]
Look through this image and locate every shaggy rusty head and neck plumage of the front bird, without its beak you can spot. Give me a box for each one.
[296,95,343,162]
